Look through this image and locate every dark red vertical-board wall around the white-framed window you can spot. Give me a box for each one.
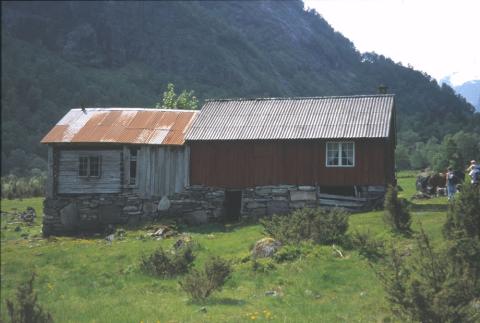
[190,140,394,188]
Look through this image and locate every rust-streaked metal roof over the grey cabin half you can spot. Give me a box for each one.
[41,108,198,145]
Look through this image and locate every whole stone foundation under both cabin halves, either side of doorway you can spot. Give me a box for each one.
[43,185,384,235]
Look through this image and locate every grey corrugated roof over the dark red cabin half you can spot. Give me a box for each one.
[185,94,394,140]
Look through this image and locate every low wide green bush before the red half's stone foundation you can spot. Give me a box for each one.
[261,208,348,244]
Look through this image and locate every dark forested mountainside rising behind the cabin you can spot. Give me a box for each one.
[1,1,480,180]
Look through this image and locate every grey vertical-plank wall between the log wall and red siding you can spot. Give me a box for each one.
[137,146,189,198]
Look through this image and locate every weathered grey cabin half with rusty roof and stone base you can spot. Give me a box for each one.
[41,108,198,232]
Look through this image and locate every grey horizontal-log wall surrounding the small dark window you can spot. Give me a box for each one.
[57,150,122,194]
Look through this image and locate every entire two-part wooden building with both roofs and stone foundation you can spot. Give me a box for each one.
[42,95,395,235]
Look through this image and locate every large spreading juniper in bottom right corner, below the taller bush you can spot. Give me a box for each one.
[377,229,480,323]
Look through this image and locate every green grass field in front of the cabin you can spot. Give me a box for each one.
[1,173,446,322]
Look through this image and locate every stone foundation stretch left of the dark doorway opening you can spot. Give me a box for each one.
[43,186,225,236]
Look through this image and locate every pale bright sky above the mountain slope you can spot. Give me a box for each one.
[304,0,480,85]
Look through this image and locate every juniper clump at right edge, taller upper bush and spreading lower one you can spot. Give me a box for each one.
[377,184,480,323]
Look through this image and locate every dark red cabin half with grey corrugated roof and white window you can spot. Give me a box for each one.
[186,95,396,218]
